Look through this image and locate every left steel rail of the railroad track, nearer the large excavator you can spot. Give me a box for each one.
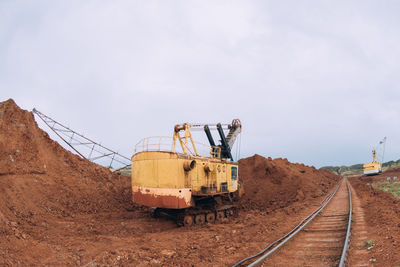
[233,179,343,267]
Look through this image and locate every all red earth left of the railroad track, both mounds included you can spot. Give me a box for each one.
[0,99,339,266]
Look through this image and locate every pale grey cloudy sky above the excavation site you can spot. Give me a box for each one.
[0,0,400,167]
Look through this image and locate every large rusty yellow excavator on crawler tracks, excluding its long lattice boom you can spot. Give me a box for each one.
[132,119,243,226]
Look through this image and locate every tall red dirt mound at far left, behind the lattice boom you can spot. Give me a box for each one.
[0,99,131,265]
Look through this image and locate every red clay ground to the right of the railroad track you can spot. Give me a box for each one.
[349,169,400,266]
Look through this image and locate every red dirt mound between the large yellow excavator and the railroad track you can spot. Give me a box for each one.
[239,155,340,212]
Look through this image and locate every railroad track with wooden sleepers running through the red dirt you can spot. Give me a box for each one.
[234,179,352,267]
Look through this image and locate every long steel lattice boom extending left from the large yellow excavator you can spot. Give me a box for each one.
[32,108,131,170]
